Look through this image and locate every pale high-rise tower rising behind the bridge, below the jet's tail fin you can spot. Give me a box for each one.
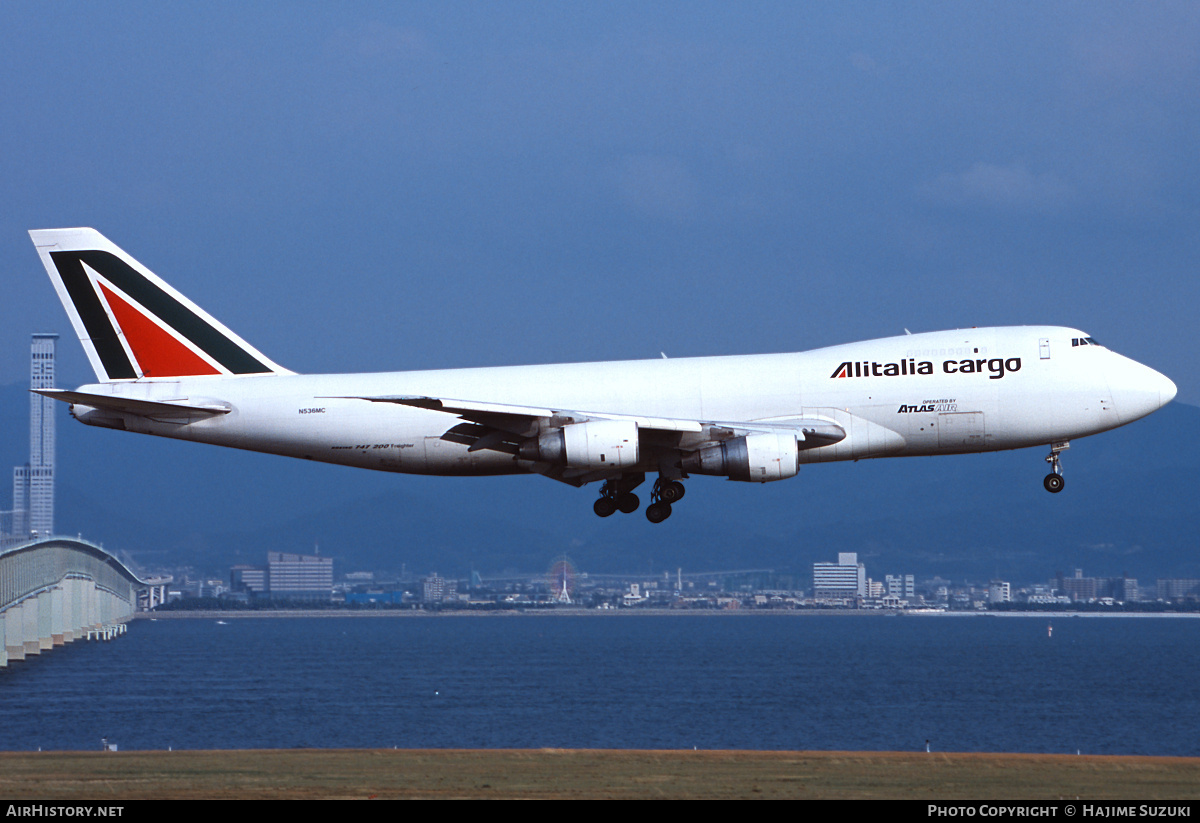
[12,335,59,537]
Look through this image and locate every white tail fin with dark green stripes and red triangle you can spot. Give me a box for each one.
[29,228,290,383]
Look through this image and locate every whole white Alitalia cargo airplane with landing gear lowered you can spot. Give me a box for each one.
[30,228,1176,523]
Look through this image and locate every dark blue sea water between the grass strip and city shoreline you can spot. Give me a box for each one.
[0,613,1200,756]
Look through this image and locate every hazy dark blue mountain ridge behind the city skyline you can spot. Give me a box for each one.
[0,385,1200,584]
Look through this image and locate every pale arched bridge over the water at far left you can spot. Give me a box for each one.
[0,537,166,667]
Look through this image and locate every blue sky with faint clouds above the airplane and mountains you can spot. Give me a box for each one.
[0,0,1200,403]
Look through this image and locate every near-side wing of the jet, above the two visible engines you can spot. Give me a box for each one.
[333,395,846,486]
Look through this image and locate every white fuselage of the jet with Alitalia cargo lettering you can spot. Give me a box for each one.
[65,326,1175,475]
